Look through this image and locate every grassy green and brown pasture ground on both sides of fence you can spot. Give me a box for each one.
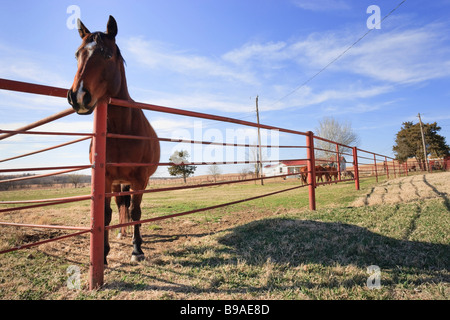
[0,172,450,300]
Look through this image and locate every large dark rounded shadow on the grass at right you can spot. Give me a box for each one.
[219,219,450,272]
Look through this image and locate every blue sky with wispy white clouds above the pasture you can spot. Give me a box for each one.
[0,0,450,175]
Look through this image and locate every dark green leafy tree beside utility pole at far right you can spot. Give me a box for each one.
[392,121,450,170]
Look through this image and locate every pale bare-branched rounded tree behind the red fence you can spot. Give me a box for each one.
[314,117,359,158]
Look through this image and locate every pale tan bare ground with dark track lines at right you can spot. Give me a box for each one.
[351,172,450,207]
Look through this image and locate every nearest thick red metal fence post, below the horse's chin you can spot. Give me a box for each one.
[89,103,108,290]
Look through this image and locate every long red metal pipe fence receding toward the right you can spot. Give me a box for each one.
[0,79,432,289]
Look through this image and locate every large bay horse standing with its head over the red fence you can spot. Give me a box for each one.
[67,16,160,264]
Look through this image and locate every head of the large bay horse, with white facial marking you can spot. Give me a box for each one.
[67,16,123,114]
